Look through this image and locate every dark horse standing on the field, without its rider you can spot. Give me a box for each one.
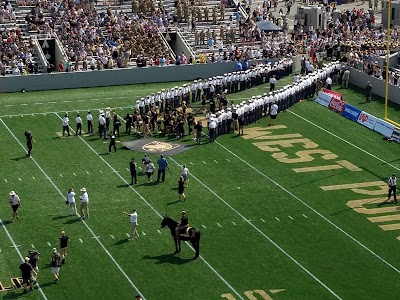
[161,215,201,259]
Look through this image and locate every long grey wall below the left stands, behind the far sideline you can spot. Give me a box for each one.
[0,62,235,93]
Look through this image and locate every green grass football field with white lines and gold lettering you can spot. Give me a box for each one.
[0,79,400,300]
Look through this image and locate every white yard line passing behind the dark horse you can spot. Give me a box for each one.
[51,114,244,300]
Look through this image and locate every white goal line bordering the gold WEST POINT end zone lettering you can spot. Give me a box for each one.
[208,126,400,274]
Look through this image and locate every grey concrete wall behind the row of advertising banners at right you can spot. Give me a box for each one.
[348,67,400,104]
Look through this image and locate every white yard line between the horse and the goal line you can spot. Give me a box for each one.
[169,156,342,299]
